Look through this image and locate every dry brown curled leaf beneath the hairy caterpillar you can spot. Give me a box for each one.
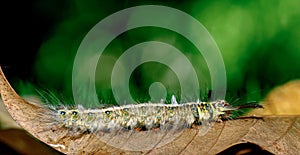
[0,67,300,154]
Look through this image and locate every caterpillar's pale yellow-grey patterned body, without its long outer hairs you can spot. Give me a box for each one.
[55,96,235,133]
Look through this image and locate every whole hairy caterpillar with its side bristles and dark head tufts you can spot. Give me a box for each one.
[20,86,262,136]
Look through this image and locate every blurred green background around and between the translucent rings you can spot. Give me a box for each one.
[2,0,300,103]
